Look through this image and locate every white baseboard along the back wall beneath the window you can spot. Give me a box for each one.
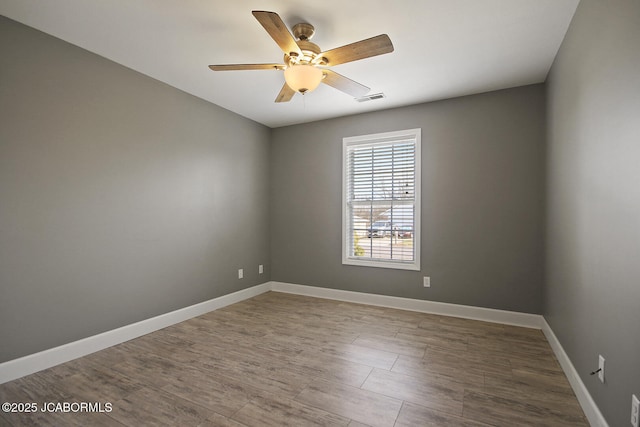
[269,282,543,329]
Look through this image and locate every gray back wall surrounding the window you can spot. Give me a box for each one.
[271,85,545,313]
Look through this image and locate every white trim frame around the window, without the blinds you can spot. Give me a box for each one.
[342,128,422,271]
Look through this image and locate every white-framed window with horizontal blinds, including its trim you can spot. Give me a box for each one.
[342,129,420,270]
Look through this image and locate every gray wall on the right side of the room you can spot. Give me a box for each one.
[544,0,640,426]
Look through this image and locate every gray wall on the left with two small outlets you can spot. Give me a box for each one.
[0,17,270,362]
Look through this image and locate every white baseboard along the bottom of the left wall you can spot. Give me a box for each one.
[0,283,271,384]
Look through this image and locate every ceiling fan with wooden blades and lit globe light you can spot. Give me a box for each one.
[209,10,393,102]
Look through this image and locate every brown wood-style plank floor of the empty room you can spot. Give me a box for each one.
[0,292,588,427]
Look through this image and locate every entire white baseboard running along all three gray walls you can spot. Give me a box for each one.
[0,282,608,427]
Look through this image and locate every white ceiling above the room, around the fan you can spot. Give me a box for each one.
[0,0,579,127]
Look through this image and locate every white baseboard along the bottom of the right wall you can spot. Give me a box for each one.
[542,318,609,427]
